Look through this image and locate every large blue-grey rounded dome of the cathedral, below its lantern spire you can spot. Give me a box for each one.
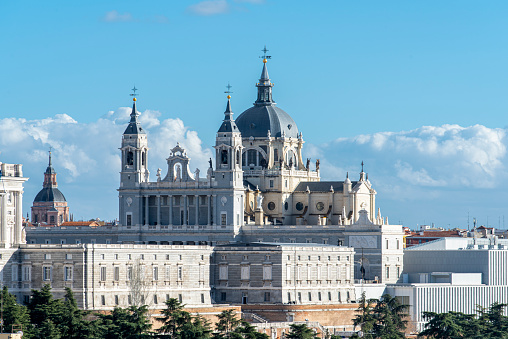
[235,104,298,138]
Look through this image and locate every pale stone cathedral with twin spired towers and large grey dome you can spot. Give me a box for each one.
[119,59,383,240]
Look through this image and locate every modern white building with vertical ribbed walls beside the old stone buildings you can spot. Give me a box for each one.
[386,237,508,330]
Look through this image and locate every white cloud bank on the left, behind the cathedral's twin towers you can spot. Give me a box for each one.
[0,107,212,219]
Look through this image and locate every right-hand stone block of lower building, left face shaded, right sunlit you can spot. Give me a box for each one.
[212,243,356,304]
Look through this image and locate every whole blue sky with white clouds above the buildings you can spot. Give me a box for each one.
[0,0,508,227]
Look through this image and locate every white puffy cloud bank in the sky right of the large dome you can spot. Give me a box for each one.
[319,125,506,187]
